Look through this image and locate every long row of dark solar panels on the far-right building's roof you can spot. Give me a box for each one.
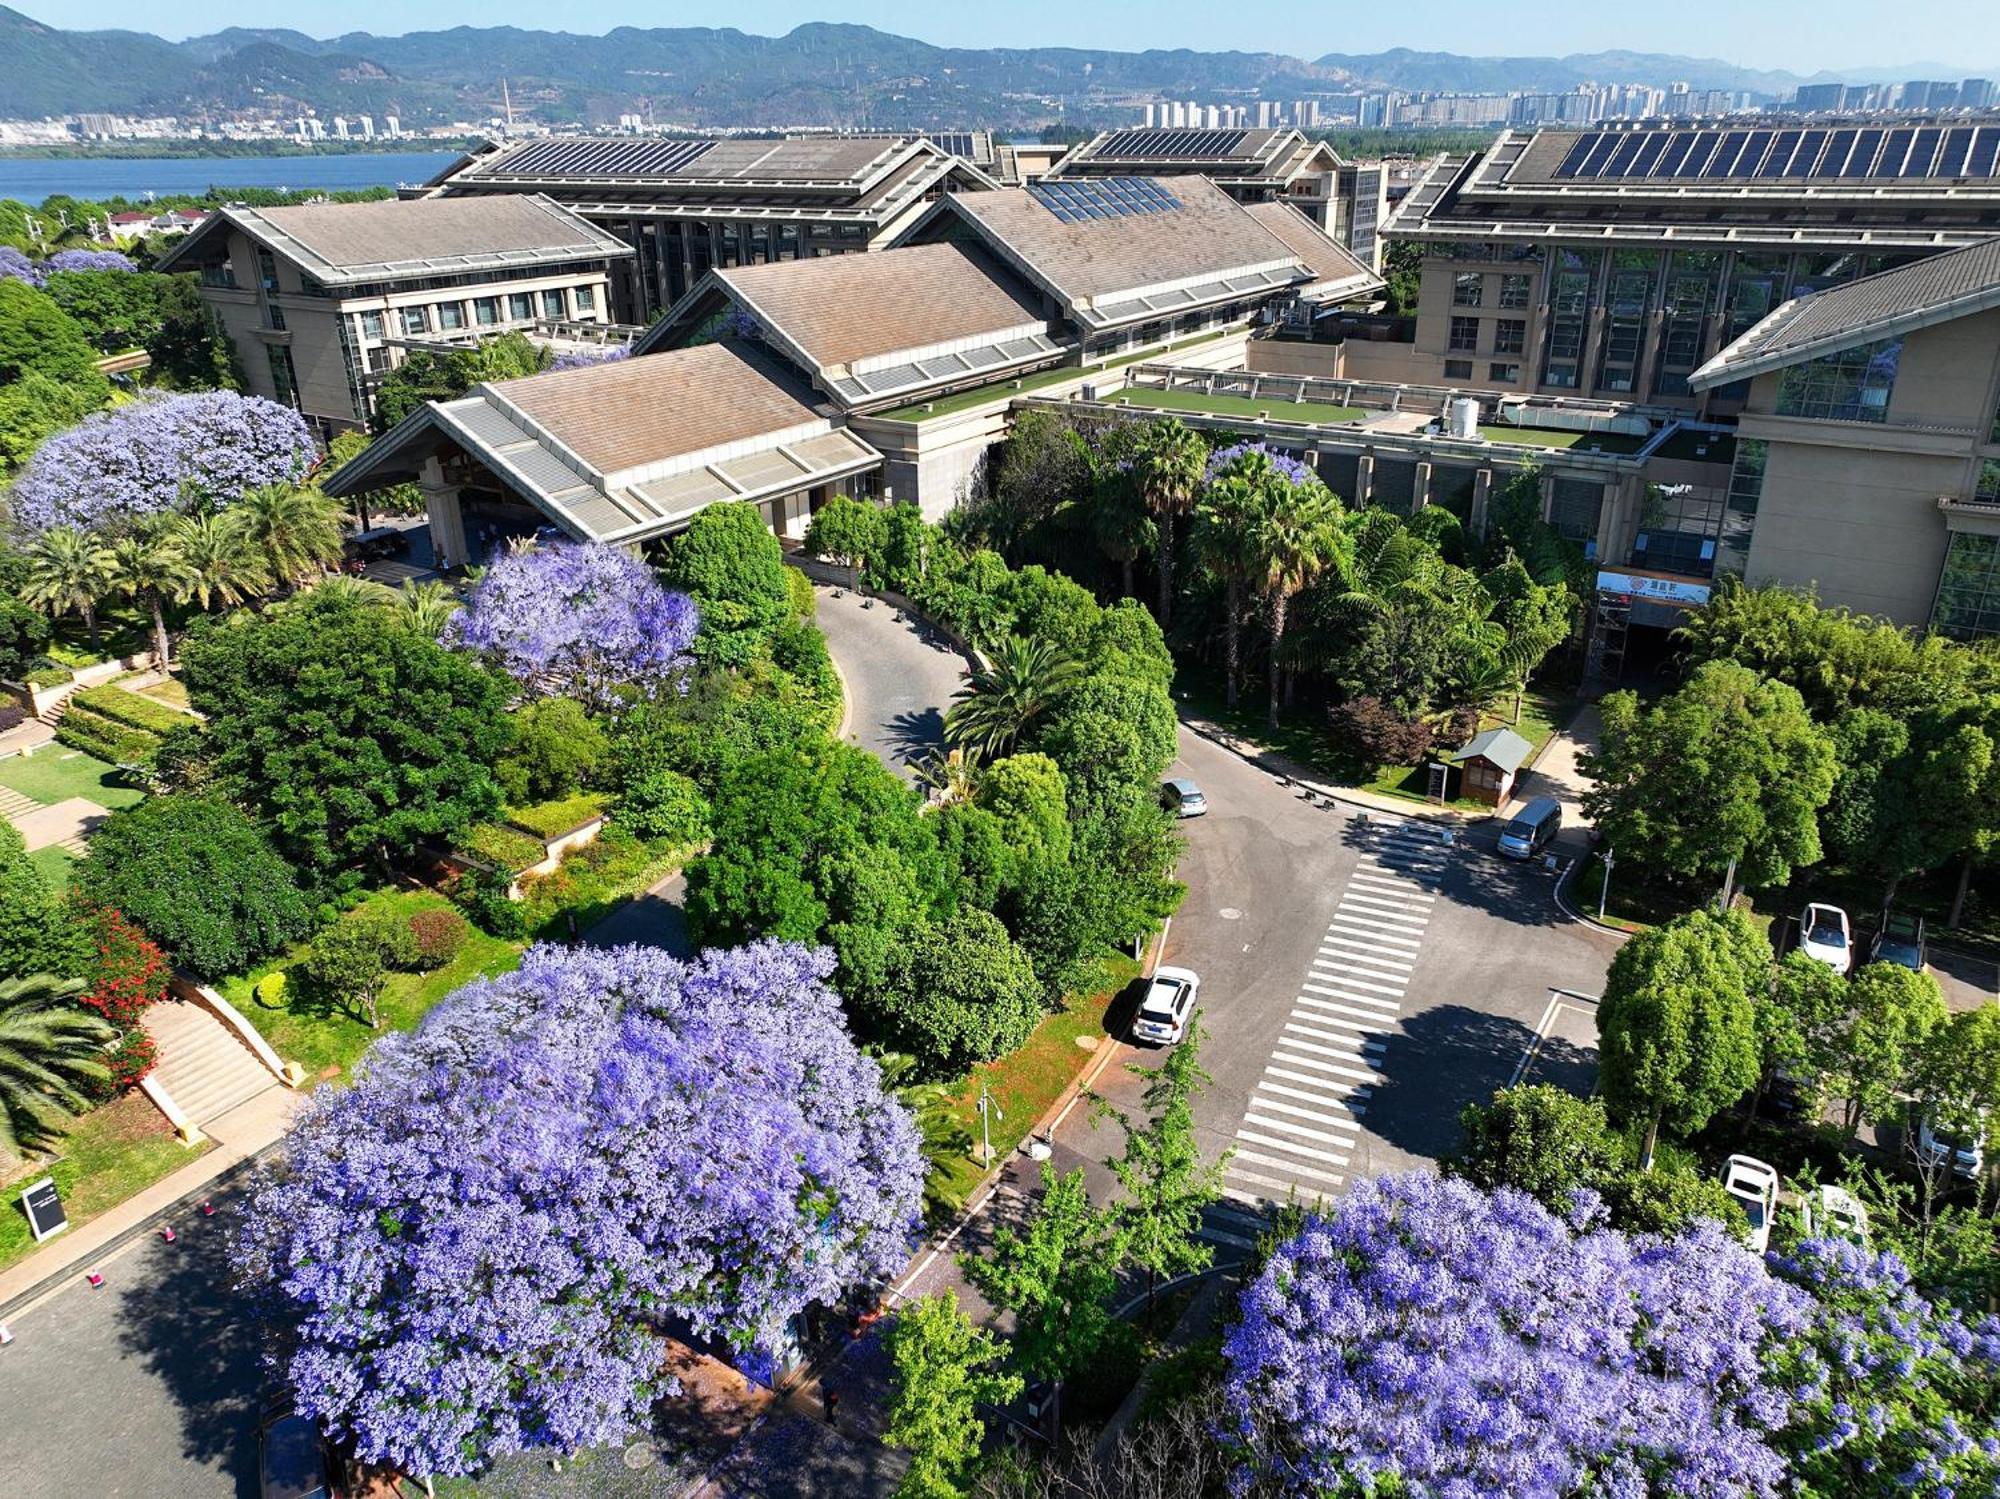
[1556,126,2000,182]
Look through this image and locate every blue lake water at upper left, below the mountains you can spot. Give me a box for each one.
[0,152,458,204]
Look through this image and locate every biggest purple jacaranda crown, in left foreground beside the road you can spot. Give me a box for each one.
[238,941,924,1475]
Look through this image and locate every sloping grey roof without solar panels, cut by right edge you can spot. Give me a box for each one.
[1688,238,2000,390]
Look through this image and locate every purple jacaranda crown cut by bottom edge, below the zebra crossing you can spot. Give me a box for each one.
[1224,1173,1812,1499]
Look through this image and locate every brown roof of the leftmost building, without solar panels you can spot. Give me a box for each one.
[160,194,632,286]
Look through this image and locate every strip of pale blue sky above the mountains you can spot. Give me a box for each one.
[39,0,2000,76]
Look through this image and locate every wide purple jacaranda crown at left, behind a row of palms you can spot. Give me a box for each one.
[12,390,316,532]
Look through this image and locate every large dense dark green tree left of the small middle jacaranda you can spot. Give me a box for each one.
[182,590,508,873]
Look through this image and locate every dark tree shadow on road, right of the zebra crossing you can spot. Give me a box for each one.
[1362,1005,1596,1159]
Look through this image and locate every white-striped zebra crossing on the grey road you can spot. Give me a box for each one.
[1206,823,1450,1247]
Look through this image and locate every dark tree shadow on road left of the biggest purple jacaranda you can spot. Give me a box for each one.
[118,1203,264,1499]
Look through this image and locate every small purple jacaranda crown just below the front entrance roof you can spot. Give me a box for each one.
[442,542,700,708]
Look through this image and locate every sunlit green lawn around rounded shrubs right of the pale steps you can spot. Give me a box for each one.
[216,889,526,1079]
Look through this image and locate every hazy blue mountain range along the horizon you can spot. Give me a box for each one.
[0,6,1984,128]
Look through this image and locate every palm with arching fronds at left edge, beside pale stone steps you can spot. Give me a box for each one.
[0,973,118,1155]
